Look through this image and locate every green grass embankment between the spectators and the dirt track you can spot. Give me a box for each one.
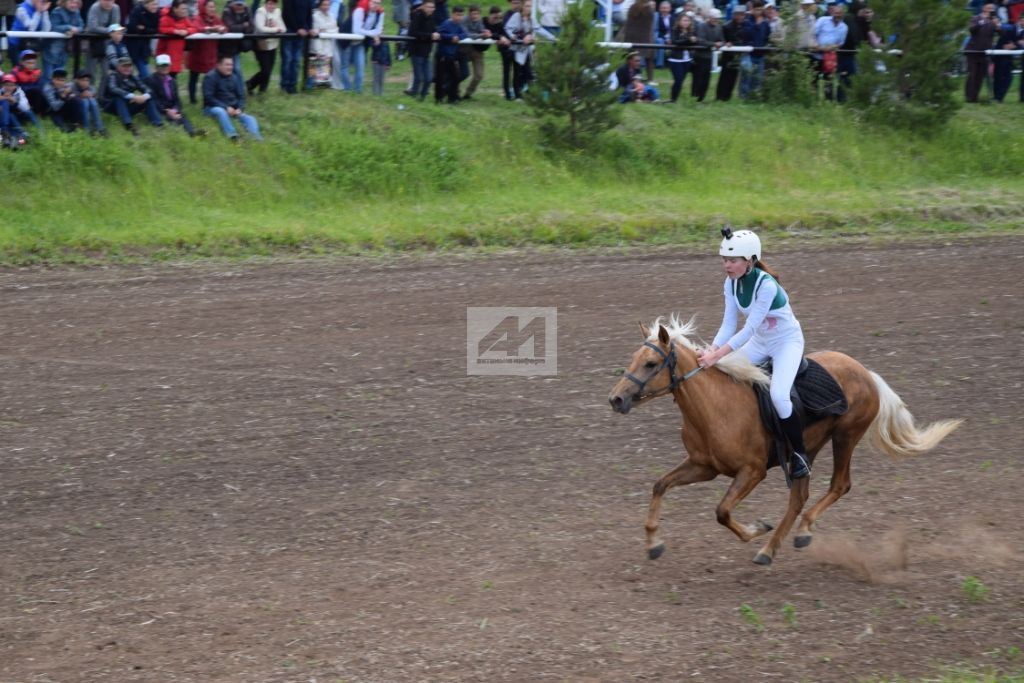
[0,72,1024,263]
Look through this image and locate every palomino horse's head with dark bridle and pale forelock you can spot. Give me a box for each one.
[608,323,679,415]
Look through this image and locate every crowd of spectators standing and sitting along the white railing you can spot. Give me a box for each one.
[0,0,1024,146]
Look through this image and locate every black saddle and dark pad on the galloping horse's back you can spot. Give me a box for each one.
[754,358,850,469]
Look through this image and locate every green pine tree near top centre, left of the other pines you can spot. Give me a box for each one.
[525,0,623,150]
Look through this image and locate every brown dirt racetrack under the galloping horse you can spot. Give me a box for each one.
[0,237,1024,683]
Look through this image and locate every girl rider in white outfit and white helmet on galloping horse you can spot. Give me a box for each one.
[698,228,810,479]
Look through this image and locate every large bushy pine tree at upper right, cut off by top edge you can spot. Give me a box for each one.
[852,0,966,134]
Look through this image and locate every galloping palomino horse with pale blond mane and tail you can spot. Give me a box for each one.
[608,315,963,564]
